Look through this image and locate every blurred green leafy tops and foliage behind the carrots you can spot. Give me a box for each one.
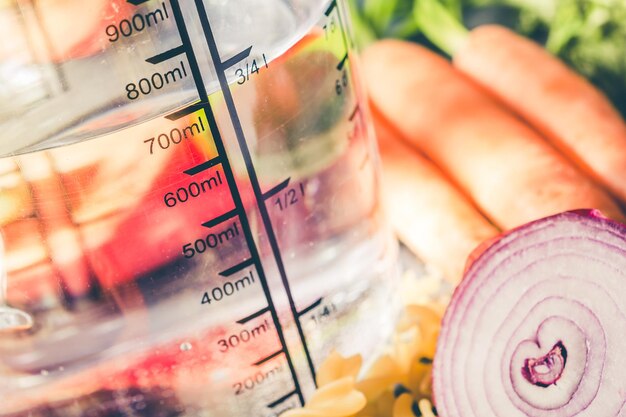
[348,0,626,116]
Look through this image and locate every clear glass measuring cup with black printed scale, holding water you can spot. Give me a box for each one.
[0,0,396,416]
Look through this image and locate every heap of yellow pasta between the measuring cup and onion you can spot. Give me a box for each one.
[283,274,445,417]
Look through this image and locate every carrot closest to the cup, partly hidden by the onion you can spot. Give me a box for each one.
[374,109,498,284]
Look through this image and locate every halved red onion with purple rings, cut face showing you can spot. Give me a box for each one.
[433,210,626,417]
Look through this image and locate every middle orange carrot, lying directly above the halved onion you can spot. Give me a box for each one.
[363,40,622,228]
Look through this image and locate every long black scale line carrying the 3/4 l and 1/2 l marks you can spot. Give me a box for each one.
[190,0,317,386]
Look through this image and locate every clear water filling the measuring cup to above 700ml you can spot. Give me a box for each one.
[0,1,395,416]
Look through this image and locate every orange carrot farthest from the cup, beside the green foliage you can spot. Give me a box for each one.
[454,25,626,201]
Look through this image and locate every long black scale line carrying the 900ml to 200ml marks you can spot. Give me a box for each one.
[162,0,304,405]
